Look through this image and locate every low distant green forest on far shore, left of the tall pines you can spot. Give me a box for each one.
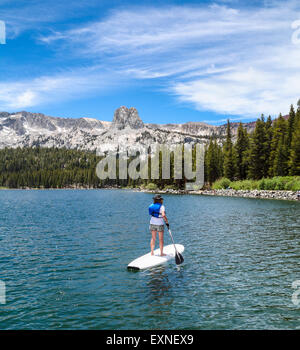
[0,147,185,188]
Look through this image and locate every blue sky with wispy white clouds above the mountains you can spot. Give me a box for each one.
[0,0,300,125]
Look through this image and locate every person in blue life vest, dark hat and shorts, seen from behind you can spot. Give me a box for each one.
[149,194,170,256]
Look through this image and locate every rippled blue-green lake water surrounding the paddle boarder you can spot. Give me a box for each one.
[0,190,300,329]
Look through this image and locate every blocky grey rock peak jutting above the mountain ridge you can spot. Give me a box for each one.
[112,106,144,130]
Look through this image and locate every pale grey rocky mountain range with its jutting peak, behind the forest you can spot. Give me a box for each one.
[0,106,255,152]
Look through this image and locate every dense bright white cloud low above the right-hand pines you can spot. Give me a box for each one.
[173,68,300,118]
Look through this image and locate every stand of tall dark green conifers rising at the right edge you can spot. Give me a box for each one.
[205,100,300,184]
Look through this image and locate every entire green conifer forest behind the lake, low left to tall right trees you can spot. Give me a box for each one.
[0,100,300,189]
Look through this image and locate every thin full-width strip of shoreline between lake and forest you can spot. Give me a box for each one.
[0,186,300,201]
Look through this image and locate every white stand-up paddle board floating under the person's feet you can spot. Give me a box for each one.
[127,244,184,270]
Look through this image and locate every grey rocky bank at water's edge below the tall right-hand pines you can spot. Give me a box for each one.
[140,189,300,201]
